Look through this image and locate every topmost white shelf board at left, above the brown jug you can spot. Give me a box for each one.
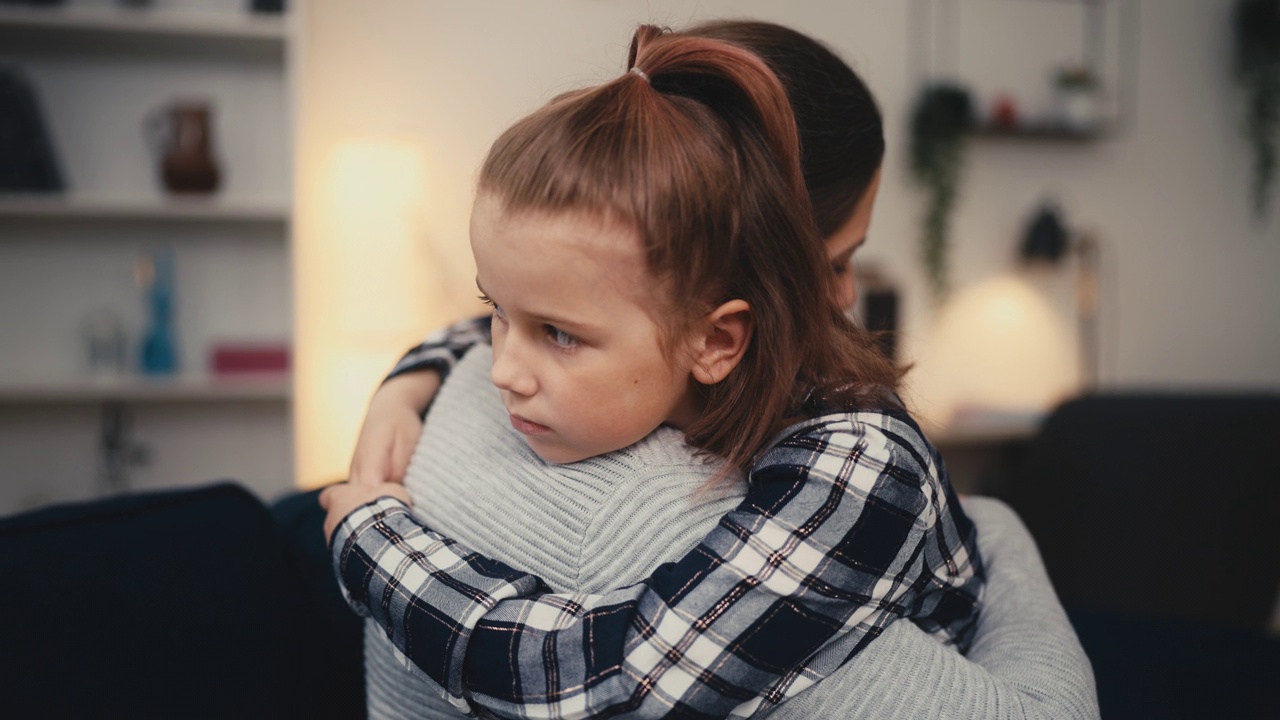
[0,6,288,45]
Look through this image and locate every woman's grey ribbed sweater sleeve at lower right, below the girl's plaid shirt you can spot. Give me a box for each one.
[771,497,1100,720]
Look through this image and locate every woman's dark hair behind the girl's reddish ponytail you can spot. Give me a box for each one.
[685,20,884,238]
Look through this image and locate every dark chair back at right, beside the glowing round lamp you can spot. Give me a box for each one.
[1006,393,1280,630]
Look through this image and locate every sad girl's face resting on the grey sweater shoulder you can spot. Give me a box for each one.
[471,193,694,462]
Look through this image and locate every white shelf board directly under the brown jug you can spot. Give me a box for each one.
[0,193,289,223]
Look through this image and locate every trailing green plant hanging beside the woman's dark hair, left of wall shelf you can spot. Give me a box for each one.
[910,83,974,300]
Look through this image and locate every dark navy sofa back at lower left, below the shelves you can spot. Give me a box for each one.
[0,483,365,719]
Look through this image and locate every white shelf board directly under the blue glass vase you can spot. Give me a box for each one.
[0,373,293,405]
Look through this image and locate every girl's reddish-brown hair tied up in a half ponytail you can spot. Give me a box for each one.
[479,26,899,469]
